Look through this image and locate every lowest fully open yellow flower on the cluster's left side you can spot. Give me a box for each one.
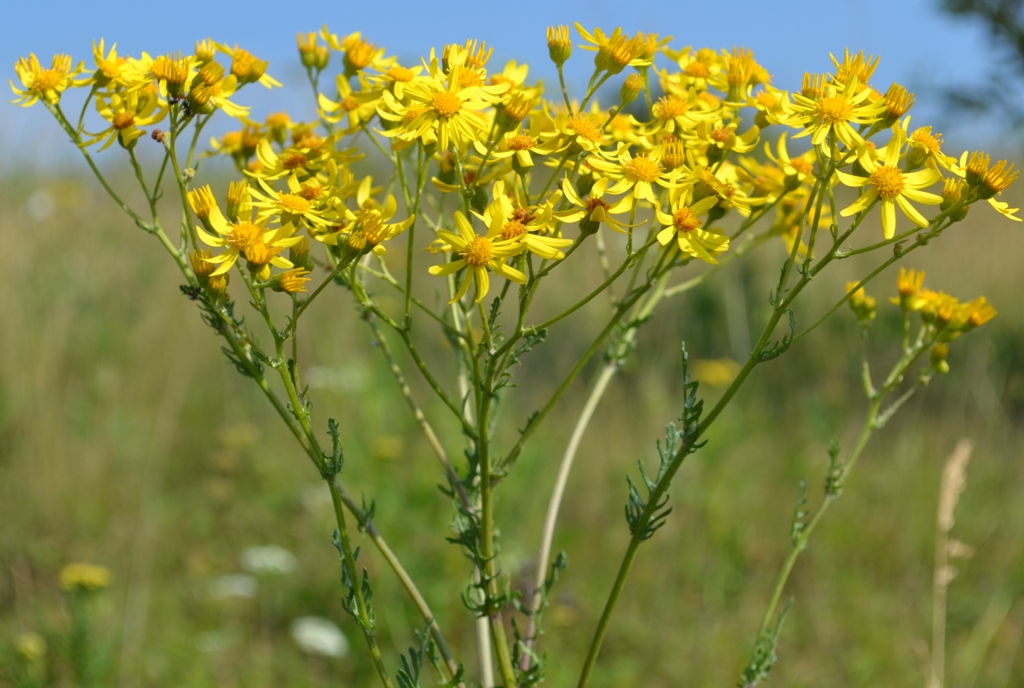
[196,206,302,280]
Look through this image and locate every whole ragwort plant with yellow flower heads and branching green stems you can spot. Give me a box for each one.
[12,24,1019,688]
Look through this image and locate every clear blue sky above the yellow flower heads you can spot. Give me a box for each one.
[0,0,1007,165]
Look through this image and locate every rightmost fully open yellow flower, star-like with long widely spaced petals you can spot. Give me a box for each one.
[836,127,942,240]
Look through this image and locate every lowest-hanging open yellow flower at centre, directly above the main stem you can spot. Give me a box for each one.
[429,211,526,303]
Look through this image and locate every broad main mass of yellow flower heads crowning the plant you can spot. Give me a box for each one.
[12,25,1019,301]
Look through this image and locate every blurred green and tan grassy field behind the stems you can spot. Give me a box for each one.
[0,167,1024,688]
